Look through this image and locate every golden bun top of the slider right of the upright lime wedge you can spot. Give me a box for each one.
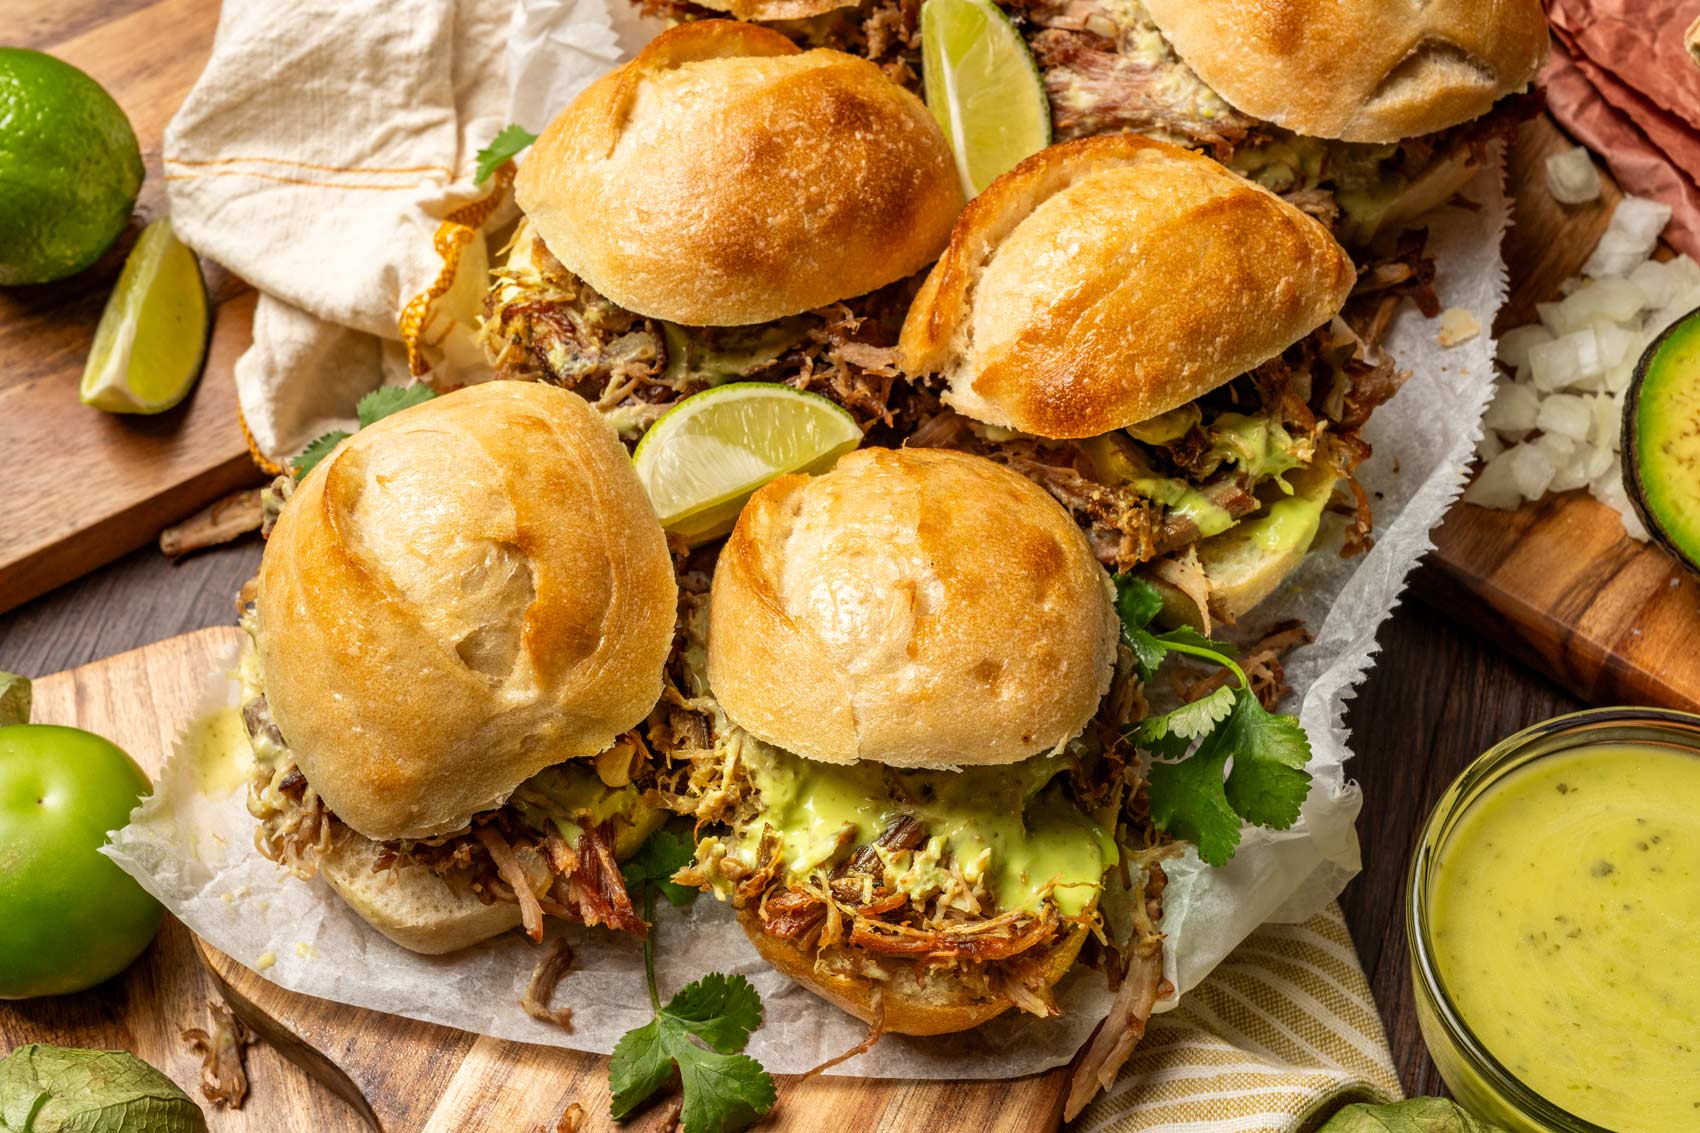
[898,134,1357,437]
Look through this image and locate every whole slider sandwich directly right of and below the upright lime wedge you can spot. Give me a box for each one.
[898,134,1366,631]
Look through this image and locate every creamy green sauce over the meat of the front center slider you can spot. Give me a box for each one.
[731,740,1117,915]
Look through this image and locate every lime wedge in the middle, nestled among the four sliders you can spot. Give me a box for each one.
[632,381,862,543]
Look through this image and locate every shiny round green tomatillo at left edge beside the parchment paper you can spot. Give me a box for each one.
[0,723,163,999]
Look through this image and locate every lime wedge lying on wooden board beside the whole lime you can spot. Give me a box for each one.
[82,218,207,413]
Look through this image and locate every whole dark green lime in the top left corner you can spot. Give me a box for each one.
[0,48,143,286]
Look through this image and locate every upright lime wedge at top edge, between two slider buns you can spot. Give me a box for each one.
[921,0,1051,197]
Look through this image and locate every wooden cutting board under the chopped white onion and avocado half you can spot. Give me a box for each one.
[1413,117,1700,711]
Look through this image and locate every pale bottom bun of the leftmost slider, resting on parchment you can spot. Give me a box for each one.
[318,830,520,956]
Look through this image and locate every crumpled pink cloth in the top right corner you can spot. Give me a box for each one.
[1540,0,1700,257]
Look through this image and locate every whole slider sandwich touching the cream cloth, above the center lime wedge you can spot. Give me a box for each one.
[479,20,962,441]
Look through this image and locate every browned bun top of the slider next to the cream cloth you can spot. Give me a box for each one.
[515,20,962,327]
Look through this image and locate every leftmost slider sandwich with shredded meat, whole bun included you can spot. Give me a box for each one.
[241,381,678,953]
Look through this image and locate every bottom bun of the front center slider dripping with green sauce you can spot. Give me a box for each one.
[738,910,1086,1034]
